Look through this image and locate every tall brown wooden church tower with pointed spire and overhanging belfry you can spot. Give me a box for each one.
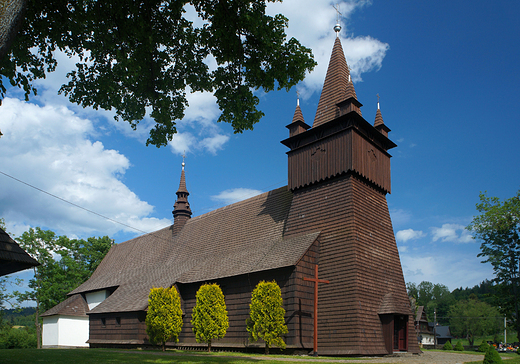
[282,25,419,355]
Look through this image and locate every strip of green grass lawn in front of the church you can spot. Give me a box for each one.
[0,349,374,364]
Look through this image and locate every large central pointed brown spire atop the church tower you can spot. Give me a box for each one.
[313,37,361,127]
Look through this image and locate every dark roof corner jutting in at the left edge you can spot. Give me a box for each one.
[0,228,40,276]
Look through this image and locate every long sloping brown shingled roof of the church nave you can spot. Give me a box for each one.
[70,187,319,313]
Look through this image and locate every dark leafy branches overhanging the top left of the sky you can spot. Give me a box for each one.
[0,0,316,147]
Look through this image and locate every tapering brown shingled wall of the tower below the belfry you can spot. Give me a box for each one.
[286,174,418,355]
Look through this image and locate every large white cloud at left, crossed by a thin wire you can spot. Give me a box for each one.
[0,98,170,236]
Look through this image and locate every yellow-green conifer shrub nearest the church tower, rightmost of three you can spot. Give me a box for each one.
[246,281,288,354]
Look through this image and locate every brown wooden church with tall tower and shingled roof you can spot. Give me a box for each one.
[43,28,419,355]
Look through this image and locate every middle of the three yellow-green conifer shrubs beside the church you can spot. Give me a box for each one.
[191,284,229,352]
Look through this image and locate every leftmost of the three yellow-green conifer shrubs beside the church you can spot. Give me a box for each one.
[146,287,182,351]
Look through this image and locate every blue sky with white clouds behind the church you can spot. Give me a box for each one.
[0,0,520,296]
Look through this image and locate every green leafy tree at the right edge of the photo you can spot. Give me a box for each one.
[467,190,520,332]
